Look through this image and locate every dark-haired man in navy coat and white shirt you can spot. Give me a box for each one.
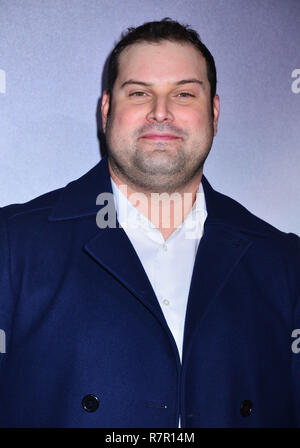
[0,19,300,428]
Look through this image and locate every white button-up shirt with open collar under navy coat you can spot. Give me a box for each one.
[111,179,207,359]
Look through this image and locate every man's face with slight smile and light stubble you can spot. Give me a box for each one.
[102,41,219,192]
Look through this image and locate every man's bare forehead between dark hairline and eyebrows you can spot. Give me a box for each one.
[116,41,207,85]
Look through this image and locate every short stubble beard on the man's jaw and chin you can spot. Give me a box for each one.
[105,112,213,193]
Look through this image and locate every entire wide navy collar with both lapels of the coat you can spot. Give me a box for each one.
[49,158,271,365]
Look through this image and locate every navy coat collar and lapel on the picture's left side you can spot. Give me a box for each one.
[48,157,171,335]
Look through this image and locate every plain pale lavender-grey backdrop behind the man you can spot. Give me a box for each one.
[0,0,300,234]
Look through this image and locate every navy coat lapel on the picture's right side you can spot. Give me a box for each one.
[183,176,265,359]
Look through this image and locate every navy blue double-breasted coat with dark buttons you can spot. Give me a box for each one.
[0,158,300,428]
